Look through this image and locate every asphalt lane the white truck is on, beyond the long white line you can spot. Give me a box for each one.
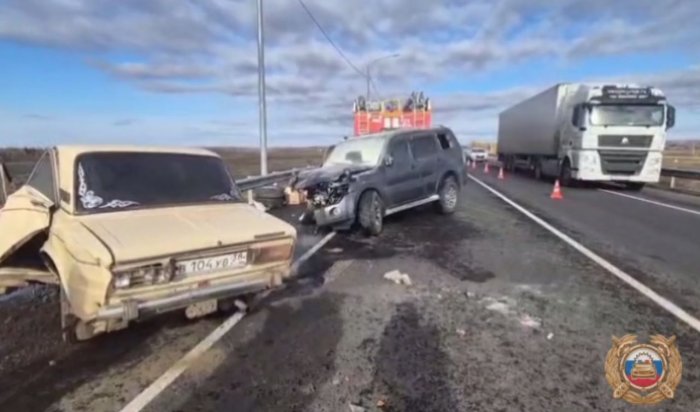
[472,169,700,317]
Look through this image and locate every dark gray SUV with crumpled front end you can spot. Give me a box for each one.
[292,126,466,235]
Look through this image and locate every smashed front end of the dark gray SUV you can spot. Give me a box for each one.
[292,168,361,229]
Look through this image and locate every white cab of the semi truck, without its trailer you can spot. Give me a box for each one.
[560,85,675,189]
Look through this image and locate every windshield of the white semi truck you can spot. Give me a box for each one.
[591,105,664,126]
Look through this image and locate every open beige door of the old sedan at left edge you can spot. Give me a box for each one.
[0,152,56,289]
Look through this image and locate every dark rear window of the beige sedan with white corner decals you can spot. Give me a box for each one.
[75,152,241,211]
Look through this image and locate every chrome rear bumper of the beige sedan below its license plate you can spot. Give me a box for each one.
[94,272,284,322]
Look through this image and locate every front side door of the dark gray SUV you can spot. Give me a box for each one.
[384,136,423,207]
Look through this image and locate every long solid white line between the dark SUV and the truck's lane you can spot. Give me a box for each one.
[469,175,700,332]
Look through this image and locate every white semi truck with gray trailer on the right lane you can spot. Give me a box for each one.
[498,83,676,190]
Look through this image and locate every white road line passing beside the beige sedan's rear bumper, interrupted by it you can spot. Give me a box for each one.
[120,232,335,412]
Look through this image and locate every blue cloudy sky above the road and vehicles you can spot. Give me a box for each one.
[0,0,700,146]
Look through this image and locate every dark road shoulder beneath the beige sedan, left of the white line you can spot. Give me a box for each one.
[0,208,322,411]
